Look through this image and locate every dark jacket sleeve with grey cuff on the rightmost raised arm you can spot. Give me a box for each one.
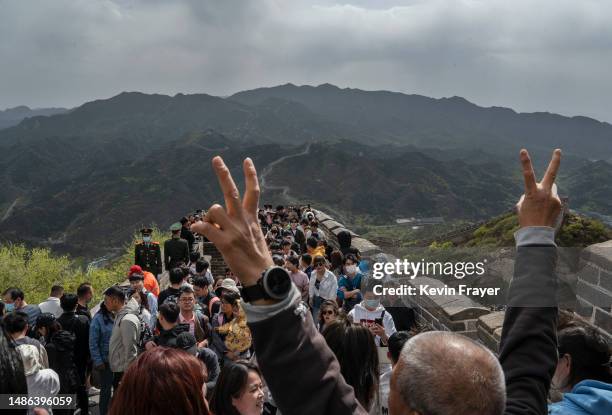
[499,228,558,415]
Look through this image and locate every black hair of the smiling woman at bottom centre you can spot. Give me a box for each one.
[210,360,262,415]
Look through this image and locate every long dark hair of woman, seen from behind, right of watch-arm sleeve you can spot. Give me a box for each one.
[322,319,379,411]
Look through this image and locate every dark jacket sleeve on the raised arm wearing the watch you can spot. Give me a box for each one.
[245,288,367,415]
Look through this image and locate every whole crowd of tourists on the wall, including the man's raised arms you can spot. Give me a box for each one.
[0,152,612,415]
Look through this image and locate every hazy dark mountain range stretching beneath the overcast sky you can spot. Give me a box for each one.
[0,84,612,256]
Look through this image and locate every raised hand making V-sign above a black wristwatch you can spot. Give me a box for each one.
[191,156,274,292]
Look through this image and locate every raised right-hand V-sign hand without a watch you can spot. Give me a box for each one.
[516,149,561,228]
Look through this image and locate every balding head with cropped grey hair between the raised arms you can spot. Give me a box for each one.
[389,331,506,415]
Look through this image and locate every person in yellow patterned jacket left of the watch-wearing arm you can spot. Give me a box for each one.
[210,291,251,362]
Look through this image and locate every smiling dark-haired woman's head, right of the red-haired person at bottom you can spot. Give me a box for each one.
[210,360,264,415]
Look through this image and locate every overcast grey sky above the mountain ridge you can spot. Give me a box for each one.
[0,0,612,121]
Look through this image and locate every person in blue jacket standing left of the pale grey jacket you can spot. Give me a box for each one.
[89,286,119,415]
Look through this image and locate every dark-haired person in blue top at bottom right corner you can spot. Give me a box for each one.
[549,323,612,415]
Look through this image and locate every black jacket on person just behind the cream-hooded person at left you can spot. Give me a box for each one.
[45,330,79,394]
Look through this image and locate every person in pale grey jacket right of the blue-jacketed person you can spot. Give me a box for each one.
[107,296,143,390]
